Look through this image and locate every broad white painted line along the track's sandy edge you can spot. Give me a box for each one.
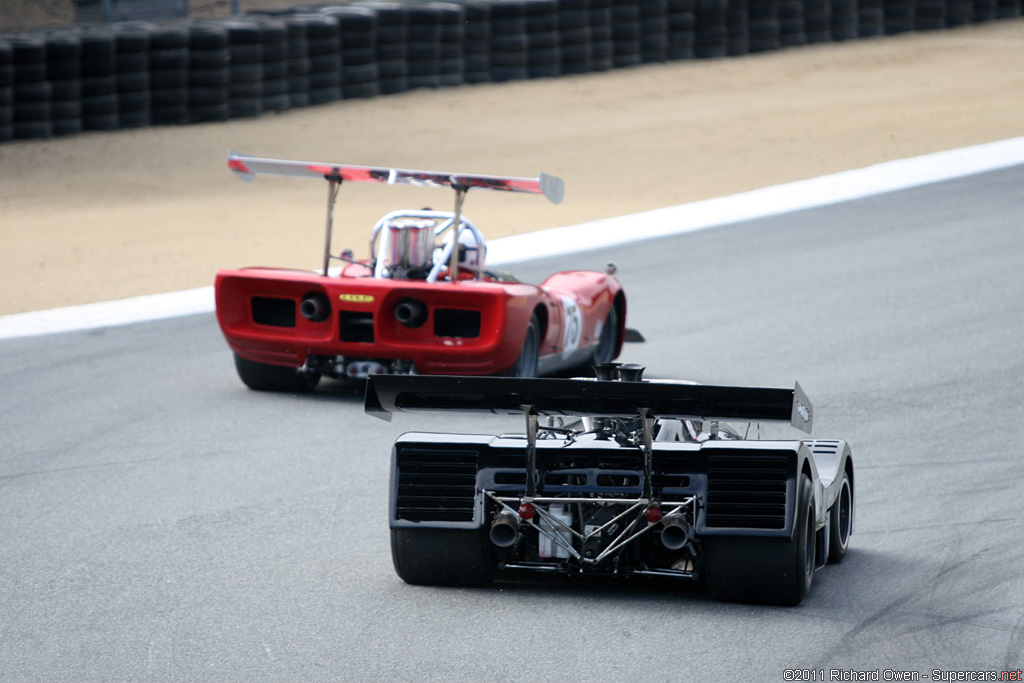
[0,137,1024,339]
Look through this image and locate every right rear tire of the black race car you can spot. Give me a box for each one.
[705,475,816,606]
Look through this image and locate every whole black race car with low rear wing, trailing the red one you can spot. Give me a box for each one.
[366,364,854,605]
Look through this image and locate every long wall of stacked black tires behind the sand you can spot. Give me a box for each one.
[0,0,1022,142]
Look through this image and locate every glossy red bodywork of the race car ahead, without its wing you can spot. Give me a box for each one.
[216,264,626,375]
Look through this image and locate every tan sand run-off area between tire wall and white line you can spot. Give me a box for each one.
[0,19,1024,314]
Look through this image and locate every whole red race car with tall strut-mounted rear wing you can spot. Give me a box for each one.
[216,152,642,391]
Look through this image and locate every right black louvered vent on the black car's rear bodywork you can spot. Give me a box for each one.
[706,451,793,529]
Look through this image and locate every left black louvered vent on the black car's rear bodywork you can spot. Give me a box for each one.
[394,446,480,522]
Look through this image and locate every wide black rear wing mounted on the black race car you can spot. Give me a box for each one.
[365,375,813,434]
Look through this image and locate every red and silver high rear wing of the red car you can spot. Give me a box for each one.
[227,151,565,204]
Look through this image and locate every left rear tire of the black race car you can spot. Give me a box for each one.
[391,528,495,587]
